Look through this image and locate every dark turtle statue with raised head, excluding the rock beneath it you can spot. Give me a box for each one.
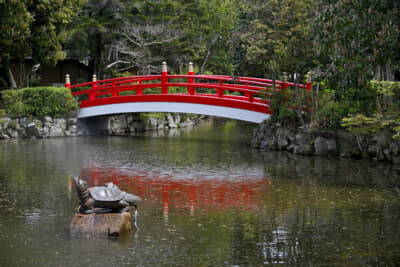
[74,177,142,215]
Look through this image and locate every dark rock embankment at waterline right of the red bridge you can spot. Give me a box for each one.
[251,121,400,164]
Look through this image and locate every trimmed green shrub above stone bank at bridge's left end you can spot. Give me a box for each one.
[2,87,78,118]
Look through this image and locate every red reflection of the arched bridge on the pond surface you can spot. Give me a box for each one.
[80,167,270,217]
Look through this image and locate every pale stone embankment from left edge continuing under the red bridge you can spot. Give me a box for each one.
[0,114,201,139]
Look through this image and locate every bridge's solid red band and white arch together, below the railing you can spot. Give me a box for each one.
[78,95,269,123]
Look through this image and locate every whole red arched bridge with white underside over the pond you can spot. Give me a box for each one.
[65,62,310,123]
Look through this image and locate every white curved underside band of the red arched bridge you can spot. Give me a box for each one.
[78,102,269,123]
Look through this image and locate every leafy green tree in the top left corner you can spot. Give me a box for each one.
[0,0,82,88]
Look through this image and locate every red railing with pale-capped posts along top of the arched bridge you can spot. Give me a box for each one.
[65,62,310,107]
